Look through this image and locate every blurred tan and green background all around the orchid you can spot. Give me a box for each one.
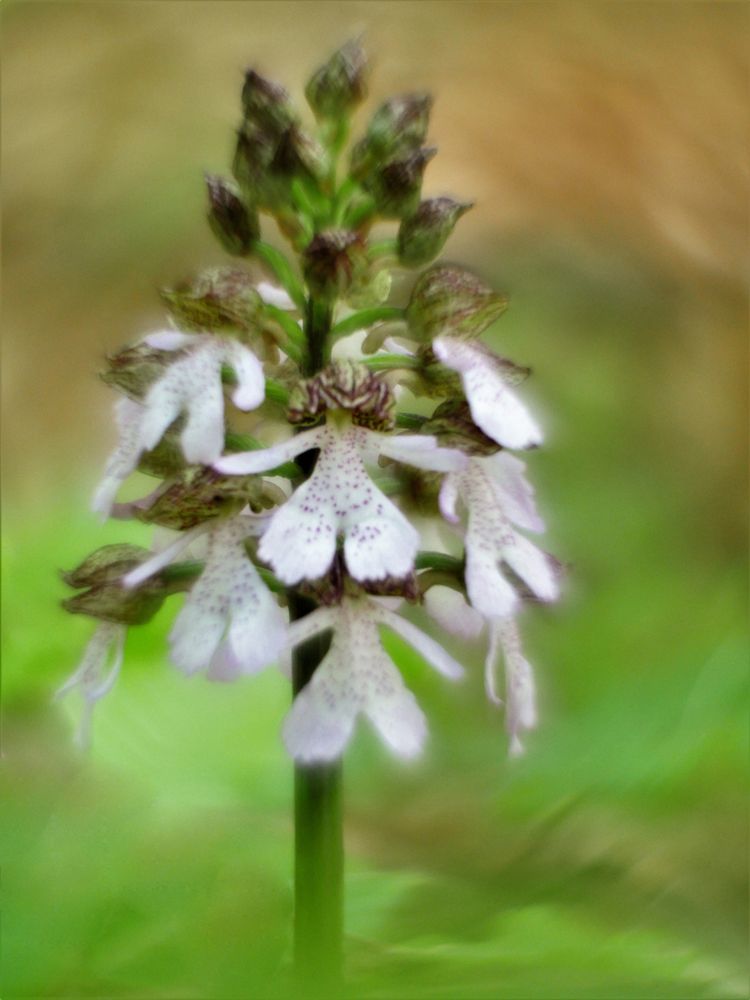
[2,2,747,1000]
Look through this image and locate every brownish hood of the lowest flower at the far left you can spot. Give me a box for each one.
[62,545,169,625]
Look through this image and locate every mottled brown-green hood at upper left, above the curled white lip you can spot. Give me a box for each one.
[160,267,263,333]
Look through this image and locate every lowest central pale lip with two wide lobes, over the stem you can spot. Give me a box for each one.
[283,597,463,763]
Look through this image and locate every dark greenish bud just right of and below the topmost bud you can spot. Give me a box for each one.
[351,94,432,180]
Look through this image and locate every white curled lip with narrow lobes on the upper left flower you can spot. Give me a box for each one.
[92,330,265,517]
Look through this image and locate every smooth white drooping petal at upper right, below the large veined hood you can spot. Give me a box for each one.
[433,336,542,448]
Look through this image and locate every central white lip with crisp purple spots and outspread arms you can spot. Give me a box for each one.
[214,415,467,585]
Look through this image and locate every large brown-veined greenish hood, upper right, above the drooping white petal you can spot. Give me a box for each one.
[406,264,508,340]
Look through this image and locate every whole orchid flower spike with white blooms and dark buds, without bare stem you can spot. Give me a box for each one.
[61,42,559,762]
